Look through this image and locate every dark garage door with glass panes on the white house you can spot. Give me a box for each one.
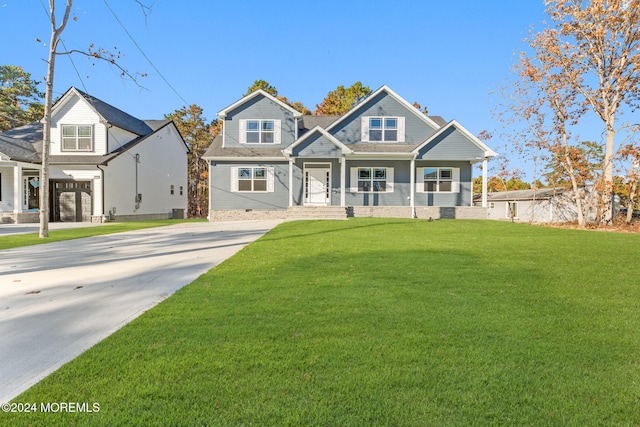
[53,181,92,222]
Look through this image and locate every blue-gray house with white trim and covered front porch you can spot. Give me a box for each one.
[204,86,496,221]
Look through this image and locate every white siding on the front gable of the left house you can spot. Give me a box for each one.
[51,95,108,156]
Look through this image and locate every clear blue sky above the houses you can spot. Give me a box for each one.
[0,0,545,176]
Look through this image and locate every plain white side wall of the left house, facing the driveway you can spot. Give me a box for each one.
[101,125,188,215]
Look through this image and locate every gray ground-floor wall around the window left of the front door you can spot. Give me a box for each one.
[209,162,290,210]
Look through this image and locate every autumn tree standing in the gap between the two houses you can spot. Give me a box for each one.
[164,104,220,218]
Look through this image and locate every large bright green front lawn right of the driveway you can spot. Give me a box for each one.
[0,219,640,426]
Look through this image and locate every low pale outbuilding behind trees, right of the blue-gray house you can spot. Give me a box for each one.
[478,188,577,223]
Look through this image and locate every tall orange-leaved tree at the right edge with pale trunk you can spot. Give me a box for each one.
[529,0,640,222]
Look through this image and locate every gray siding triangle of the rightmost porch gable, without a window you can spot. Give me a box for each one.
[418,127,484,160]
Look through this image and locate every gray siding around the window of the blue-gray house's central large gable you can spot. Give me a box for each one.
[331,92,435,145]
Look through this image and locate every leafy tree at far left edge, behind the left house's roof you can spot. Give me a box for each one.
[0,65,44,132]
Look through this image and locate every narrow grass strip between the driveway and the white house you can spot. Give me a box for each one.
[0,219,202,250]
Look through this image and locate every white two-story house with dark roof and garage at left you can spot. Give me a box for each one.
[0,88,189,222]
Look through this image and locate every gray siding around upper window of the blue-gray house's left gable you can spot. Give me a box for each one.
[223,95,296,148]
